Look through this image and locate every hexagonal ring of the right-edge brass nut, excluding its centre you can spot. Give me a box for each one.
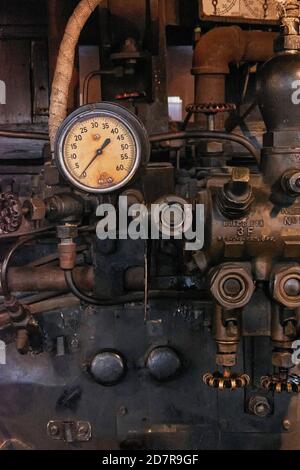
[271,266,300,308]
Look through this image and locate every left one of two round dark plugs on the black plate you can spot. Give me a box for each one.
[90,350,126,386]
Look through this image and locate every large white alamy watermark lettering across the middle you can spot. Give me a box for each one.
[96,196,204,251]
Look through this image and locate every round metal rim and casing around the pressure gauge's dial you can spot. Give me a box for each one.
[55,102,150,194]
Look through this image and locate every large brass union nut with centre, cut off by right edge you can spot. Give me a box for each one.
[271,266,300,308]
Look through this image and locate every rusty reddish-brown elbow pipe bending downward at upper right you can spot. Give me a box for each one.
[192,26,277,129]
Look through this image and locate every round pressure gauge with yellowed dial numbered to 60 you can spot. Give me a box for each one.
[55,102,150,194]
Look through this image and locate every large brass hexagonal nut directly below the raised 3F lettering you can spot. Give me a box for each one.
[210,263,255,309]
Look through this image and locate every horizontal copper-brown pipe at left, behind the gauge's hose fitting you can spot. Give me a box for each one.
[0,266,94,293]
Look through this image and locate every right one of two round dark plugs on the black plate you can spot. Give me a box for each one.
[146,346,182,382]
